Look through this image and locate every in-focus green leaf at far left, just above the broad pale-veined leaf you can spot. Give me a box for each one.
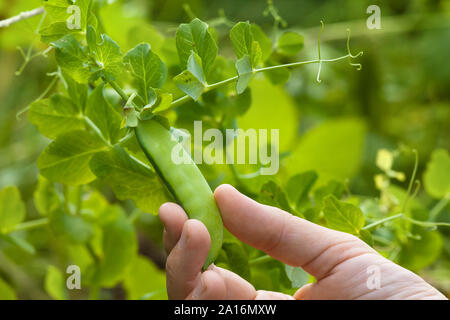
[28,94,85,139]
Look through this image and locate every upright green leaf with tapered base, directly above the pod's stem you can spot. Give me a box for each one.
[124,43,167,104]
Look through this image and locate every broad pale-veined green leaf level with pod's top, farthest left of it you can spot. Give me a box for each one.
[37,131,106,185]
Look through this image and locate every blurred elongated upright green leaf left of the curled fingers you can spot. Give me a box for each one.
[93,211,137,287]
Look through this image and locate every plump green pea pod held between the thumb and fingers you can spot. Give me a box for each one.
[136,120,223,269]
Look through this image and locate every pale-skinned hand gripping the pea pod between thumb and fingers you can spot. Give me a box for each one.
[159,185,446,300]
